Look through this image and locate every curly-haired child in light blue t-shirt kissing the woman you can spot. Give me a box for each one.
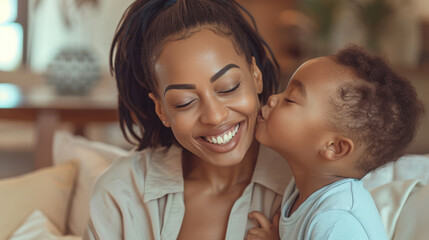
[247,46,423,240]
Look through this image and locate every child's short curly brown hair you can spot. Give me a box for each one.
[332,45,424,173]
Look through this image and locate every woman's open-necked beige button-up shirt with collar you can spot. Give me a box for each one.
[84,143,292,240]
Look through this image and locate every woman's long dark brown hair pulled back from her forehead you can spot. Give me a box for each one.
[110,0,279,150]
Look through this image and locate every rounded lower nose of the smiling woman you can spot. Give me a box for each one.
[201,100,229,125]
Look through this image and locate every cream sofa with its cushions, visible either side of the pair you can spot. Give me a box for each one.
[0,132,429,240]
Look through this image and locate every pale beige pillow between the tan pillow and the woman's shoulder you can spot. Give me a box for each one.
[53,131,127,236]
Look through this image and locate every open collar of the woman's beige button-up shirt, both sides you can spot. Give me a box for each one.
[144,145,292,202]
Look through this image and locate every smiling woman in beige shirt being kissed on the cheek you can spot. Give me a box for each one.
[85,0,290,240]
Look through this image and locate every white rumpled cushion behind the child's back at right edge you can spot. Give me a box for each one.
[362,154,429,239]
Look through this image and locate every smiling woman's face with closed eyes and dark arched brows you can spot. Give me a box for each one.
[150,29,262,166]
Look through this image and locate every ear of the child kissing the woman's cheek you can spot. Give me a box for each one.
[320,136,354,161]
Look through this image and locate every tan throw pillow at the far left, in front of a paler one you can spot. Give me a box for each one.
[0,162,77,239]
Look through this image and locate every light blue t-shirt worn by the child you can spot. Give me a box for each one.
[279,178,387,240]
